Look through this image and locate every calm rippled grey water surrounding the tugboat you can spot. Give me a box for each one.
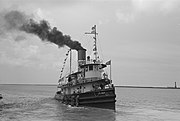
[0,85,180,121]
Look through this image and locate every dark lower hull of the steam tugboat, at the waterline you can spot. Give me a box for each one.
[55,88,116,110]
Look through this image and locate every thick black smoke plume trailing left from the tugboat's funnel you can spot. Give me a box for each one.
[4,11,83,50]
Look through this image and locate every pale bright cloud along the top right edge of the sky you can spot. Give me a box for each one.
[115,0,180,23]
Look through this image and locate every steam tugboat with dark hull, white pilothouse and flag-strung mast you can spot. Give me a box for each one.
[55,25,116,111]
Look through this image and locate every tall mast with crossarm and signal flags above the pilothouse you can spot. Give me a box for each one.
[85,25,98,60]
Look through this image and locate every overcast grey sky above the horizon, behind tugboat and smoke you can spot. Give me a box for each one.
[0,0,180,86]
